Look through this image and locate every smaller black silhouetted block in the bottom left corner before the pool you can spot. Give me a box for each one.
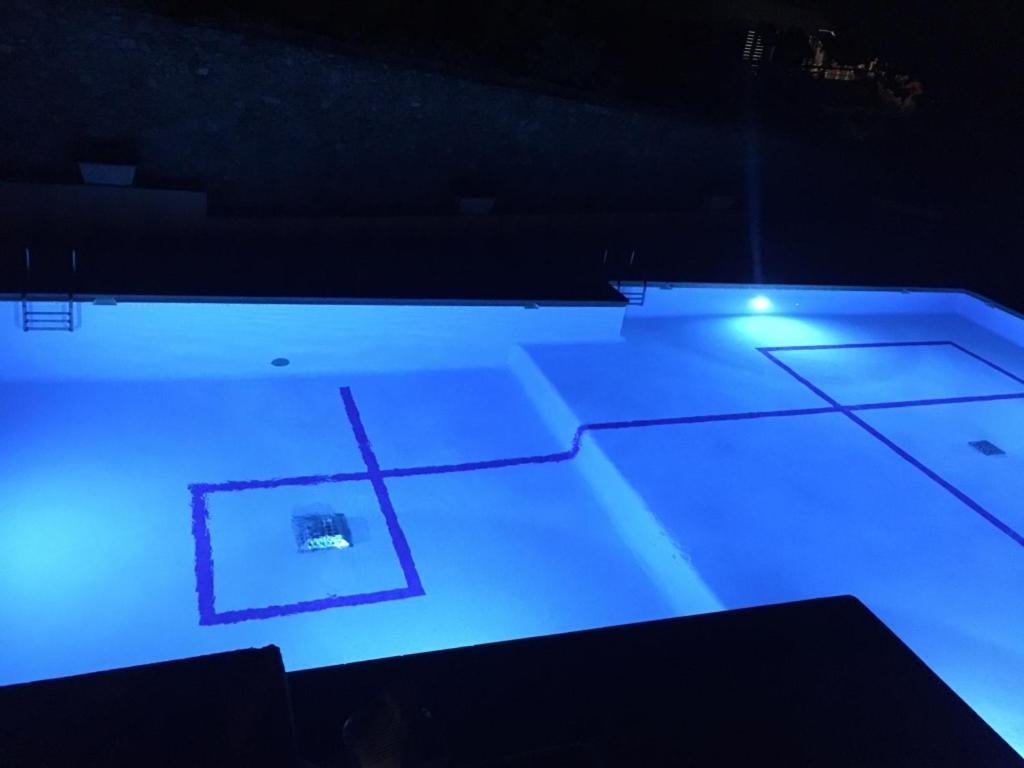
[0,645,293,768]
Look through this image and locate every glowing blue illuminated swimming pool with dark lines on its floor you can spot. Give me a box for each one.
[0,286,1024,751]
